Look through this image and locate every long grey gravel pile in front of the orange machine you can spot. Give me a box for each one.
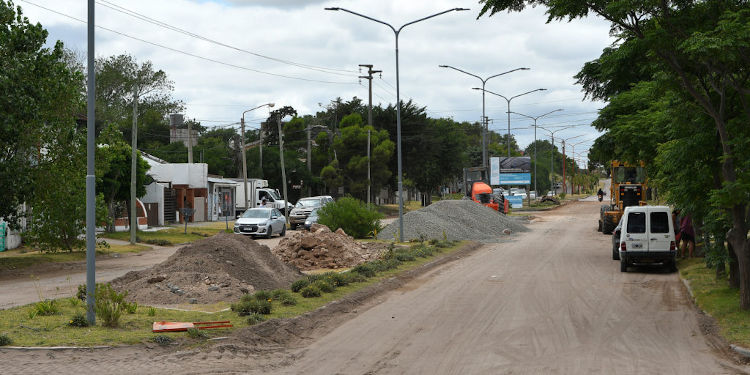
[378,200,527,241]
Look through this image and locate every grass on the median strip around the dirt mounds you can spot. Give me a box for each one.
[0,243,470,346]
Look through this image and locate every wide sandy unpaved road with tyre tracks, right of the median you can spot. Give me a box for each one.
[0,202,744,374]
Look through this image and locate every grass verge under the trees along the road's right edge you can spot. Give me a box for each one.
[677,258,750,348]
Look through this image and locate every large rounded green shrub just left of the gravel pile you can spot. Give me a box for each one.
[318,197,384,238]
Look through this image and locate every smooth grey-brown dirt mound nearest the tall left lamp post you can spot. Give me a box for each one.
[112,233,302,305]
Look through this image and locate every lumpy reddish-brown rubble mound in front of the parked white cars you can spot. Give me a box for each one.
[273,224,384,270]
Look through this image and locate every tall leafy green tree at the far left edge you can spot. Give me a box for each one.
[0,0,83,228]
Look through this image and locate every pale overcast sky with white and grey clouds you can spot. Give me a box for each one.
[16,0,612,164]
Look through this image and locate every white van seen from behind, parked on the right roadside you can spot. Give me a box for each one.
[619,206,677,272]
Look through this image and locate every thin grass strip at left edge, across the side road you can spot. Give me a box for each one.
[0,245,151,271]
